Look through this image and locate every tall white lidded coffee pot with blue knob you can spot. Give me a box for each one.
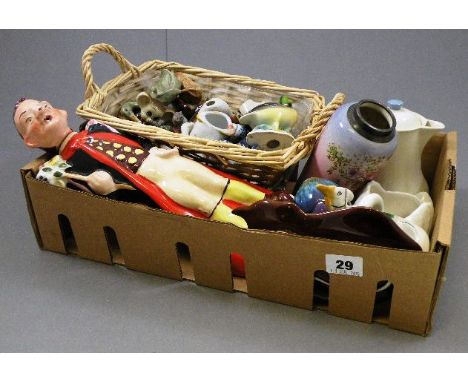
[376,100,445,194]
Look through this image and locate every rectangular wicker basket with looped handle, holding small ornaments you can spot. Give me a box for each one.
[77,44,344,187]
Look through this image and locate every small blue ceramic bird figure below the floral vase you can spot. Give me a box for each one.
[294,178,354,213]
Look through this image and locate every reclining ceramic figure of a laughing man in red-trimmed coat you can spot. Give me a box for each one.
[13,99,269,228]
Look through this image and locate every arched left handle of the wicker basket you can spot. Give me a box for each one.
[81,43,140,99]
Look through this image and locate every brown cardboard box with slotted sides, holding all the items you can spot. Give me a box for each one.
[21,133,456,335]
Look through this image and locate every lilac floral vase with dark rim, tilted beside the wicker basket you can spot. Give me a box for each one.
[301,100,397,191]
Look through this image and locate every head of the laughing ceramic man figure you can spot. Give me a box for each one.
[13,99,70,148]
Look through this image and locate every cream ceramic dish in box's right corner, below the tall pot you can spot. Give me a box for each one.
[354,181,434,251]
